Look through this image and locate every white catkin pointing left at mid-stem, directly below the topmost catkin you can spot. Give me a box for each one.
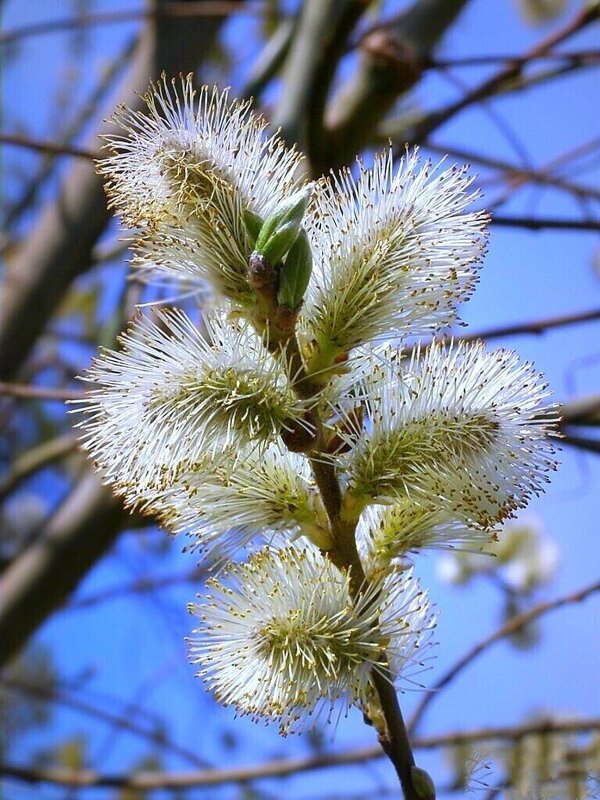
[71,311,306,506]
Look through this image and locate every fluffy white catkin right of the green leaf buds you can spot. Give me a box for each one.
[302,150,487,371]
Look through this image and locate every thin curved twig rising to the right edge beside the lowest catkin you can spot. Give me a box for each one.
[408,581,600,733]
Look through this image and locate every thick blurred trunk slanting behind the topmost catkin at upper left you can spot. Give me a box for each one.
[0,0,239,380]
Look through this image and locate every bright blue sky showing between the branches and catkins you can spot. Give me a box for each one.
[4,0,600,800]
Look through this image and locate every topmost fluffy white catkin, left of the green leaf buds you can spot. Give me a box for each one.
[99,75,304,307]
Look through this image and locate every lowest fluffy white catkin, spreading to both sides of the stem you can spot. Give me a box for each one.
[190,548,434,734]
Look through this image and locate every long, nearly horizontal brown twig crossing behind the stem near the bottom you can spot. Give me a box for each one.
[0,717,600,791]
